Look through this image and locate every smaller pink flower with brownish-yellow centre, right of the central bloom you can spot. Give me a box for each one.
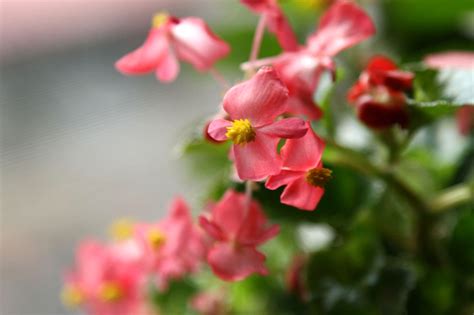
[265,122,331,210]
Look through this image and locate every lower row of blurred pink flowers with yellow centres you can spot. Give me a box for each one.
[62,194,279,315]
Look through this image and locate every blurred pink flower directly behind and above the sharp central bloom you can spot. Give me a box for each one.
[242,1,375,120]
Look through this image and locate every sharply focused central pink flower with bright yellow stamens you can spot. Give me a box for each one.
[208,67,307,180]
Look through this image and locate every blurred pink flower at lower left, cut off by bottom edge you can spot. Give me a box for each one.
[62,241,145,315]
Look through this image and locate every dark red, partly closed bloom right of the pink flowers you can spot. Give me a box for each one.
[347,56,414,129]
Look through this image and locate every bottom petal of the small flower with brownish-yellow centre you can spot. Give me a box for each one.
[280,177,324,211]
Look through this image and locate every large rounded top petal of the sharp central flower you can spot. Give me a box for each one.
[223,67,288,127]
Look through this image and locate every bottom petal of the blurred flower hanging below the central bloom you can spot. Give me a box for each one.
[207,243,268,281]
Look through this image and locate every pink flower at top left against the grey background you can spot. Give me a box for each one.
[115,13,230,82]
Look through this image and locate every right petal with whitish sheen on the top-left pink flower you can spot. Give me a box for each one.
[171,17,230,71]
